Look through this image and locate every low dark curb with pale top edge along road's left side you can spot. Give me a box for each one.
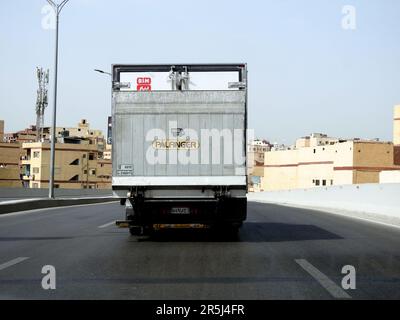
[0,197,117,214]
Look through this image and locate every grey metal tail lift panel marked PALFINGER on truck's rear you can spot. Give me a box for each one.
[113,90,246,185]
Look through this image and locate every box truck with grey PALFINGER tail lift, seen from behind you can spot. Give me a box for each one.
[112,63,248,235]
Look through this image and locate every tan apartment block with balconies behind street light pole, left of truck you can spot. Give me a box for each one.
[21,138,112,189]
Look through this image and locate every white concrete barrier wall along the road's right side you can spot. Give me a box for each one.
[247,183,400,225]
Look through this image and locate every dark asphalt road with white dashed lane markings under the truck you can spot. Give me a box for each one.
[0,203,400,299]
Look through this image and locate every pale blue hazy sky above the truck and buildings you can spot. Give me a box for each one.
[0,0,400,144]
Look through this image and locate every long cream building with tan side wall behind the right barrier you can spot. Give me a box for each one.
[262,107,400,191]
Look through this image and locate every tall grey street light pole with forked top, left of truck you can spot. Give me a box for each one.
[47,0,69,198]
